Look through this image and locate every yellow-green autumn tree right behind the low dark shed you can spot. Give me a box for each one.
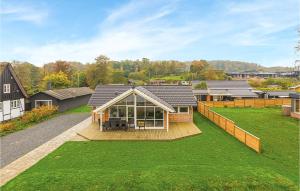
[42,72,71,89]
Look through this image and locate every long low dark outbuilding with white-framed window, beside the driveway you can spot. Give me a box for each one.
[30,87,94,112]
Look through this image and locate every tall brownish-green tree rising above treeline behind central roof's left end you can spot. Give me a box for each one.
[86,55,112,88]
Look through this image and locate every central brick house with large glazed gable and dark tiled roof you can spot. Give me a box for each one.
[89,85,196,131]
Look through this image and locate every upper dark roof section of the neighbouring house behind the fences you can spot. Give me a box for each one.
[206,80,251,89]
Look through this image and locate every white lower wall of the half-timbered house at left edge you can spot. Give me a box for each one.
[0,98,25,122]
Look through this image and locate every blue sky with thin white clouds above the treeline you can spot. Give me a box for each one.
[0,0,300,66]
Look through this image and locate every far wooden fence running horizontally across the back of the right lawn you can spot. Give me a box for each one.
[205,98,291,107]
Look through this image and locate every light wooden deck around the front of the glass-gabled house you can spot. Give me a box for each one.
[77,122,201,140]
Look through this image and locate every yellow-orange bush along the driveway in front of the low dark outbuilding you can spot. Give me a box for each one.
[21,106,57,124]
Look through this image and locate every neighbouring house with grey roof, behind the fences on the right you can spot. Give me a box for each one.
[193,80,259,101]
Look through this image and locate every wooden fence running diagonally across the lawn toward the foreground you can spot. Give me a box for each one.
[198,102,261,153]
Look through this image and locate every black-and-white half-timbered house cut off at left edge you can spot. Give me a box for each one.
[0,63,28,122]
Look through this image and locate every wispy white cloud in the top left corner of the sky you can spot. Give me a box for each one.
[0,1,48,24]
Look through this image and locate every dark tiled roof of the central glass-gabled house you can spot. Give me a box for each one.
[89,85,196,107]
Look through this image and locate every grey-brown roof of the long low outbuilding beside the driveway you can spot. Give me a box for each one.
[42,87,94,100]
